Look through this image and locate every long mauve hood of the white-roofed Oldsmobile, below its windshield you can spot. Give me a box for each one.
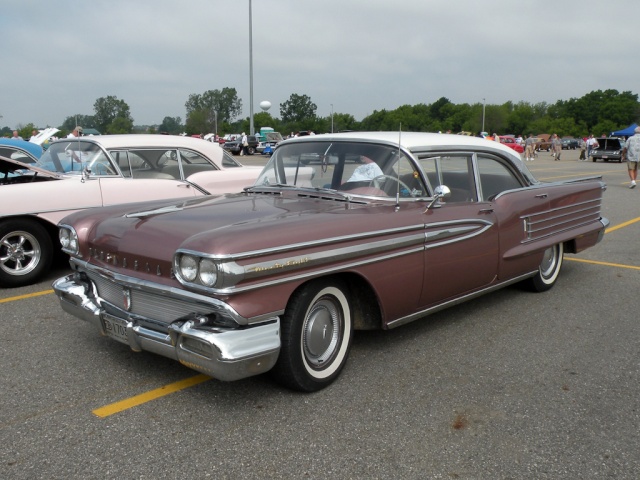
[66,193,396,281]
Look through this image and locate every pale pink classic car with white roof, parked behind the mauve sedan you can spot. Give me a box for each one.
[0,135,260,287]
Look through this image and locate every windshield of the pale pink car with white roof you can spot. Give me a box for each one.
[37,139,117,175]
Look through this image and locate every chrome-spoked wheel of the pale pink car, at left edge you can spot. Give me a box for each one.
[0,220,53,287]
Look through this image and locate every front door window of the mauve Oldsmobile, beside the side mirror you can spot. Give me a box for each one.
[419,154,478,202]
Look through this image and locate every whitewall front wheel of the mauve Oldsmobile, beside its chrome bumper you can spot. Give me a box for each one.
[271,279,353,392]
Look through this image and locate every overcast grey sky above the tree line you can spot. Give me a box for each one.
[0,0,640,128]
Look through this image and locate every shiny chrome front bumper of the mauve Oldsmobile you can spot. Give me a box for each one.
[53,273,280,381]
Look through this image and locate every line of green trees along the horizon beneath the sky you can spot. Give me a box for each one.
[2,87,640,138]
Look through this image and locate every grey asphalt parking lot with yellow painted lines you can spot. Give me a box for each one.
[0,151,640,479]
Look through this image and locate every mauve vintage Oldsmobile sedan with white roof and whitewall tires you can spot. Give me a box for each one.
[53,132,609,391]
